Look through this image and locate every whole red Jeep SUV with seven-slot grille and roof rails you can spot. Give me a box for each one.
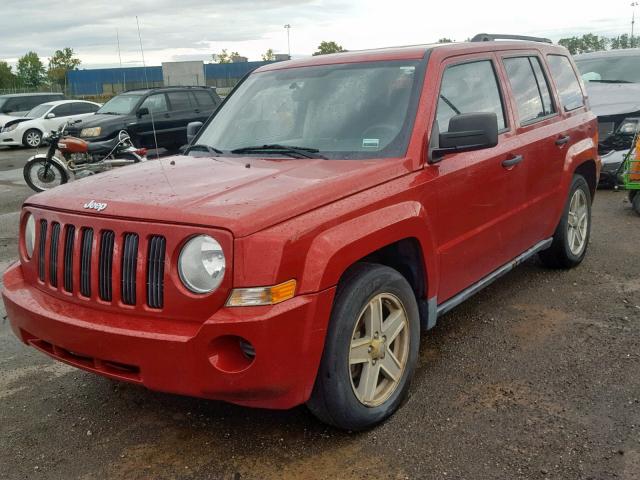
[3,35,600,430]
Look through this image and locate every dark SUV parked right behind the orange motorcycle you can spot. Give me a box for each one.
[69,87,221,150]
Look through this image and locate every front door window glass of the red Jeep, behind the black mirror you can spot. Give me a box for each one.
[436,60,506,132]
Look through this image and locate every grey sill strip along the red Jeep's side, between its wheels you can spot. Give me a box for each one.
[419,238,553,330]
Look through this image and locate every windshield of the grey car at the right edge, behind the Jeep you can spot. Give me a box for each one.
[575,55,640,83]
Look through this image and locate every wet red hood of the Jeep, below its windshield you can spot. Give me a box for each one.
[26,156,407,237]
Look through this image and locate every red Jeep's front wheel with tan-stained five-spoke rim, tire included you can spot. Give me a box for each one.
[307,263,420,431]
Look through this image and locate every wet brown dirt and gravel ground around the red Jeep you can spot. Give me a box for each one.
[0,150,640,480]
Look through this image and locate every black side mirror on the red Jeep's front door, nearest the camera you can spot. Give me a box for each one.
[429,113,498,163]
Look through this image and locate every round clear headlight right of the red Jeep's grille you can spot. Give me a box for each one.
[178,235,225,293]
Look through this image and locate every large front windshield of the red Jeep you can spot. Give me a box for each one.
[195,61,423,159]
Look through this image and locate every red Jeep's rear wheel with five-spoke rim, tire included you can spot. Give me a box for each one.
[539,175,591,268]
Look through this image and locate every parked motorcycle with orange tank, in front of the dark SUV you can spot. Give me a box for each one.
[23,120,147,192]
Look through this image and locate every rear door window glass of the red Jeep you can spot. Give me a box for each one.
[503,56,555,125]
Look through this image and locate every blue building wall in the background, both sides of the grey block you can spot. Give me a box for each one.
[67,62,273,95]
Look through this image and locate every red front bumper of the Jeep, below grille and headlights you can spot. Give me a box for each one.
[2,264,335,408]
